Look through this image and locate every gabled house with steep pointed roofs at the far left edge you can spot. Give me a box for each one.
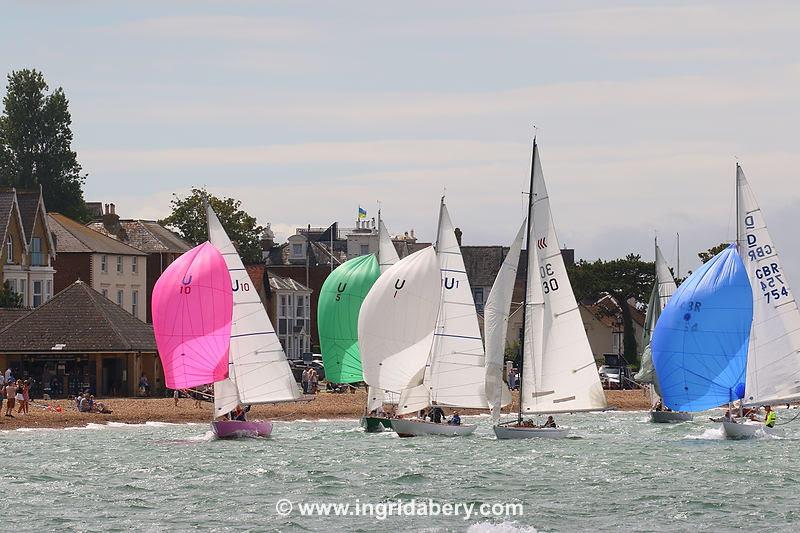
[0,189,56,307]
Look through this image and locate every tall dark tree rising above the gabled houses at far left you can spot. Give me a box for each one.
[0,69,89,221]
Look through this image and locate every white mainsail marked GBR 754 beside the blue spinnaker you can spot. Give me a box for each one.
[736,165,800,405]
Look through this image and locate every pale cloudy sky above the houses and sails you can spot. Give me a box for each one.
[0,1,800,286]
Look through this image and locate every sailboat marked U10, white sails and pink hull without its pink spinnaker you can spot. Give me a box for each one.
[206,204,302,438]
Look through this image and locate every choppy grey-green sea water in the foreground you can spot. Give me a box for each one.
[0,411,800,533]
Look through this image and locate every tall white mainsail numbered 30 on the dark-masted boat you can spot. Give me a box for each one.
[523,144,606,413]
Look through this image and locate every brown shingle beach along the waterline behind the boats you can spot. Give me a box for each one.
[0,390,650,430]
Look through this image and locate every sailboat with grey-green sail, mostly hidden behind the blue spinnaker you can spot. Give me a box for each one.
[633,239,692,424]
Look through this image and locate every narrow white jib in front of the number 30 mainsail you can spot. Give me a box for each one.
[483,220,525,421]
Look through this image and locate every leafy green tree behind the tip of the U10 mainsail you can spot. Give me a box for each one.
[159,187,264,263]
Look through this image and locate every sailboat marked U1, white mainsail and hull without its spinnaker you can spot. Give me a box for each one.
[391,198,488,437]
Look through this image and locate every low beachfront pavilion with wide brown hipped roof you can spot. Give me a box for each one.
[0,281,164,398]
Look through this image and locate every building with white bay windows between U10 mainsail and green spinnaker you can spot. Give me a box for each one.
[246,265,312,359]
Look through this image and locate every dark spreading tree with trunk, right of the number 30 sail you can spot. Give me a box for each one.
[567,254,655,365]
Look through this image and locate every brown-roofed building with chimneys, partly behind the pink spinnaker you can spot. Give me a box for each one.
[87,202,192,323]
